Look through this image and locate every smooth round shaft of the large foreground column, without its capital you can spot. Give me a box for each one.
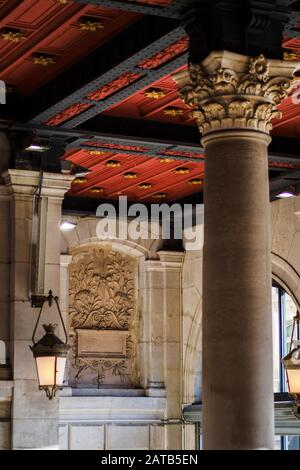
[203,130,274,449]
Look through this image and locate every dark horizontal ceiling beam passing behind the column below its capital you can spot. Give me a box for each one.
[0,118,300,167]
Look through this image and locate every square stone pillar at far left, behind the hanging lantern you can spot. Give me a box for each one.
[4,170,72,449]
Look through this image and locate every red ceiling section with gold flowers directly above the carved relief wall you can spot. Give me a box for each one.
[65,149,204,203]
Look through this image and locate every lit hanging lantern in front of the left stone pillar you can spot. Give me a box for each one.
[30,290,70,400]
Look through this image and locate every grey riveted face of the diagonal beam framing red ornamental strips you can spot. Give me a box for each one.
[30,27,187,129]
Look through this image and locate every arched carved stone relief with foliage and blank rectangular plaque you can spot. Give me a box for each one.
[69,245,138,387]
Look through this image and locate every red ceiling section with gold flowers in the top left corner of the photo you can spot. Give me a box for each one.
[0,0,140,95]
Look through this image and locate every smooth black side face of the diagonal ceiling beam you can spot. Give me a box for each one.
[19,16,179,122]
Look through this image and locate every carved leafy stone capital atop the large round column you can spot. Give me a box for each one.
[173,51,300,135]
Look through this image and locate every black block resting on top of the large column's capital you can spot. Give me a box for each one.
[182,0,292,63]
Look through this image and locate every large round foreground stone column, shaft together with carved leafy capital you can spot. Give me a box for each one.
[174,51,295,449]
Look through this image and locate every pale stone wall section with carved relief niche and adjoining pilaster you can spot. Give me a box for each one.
[59,217,185,449]
